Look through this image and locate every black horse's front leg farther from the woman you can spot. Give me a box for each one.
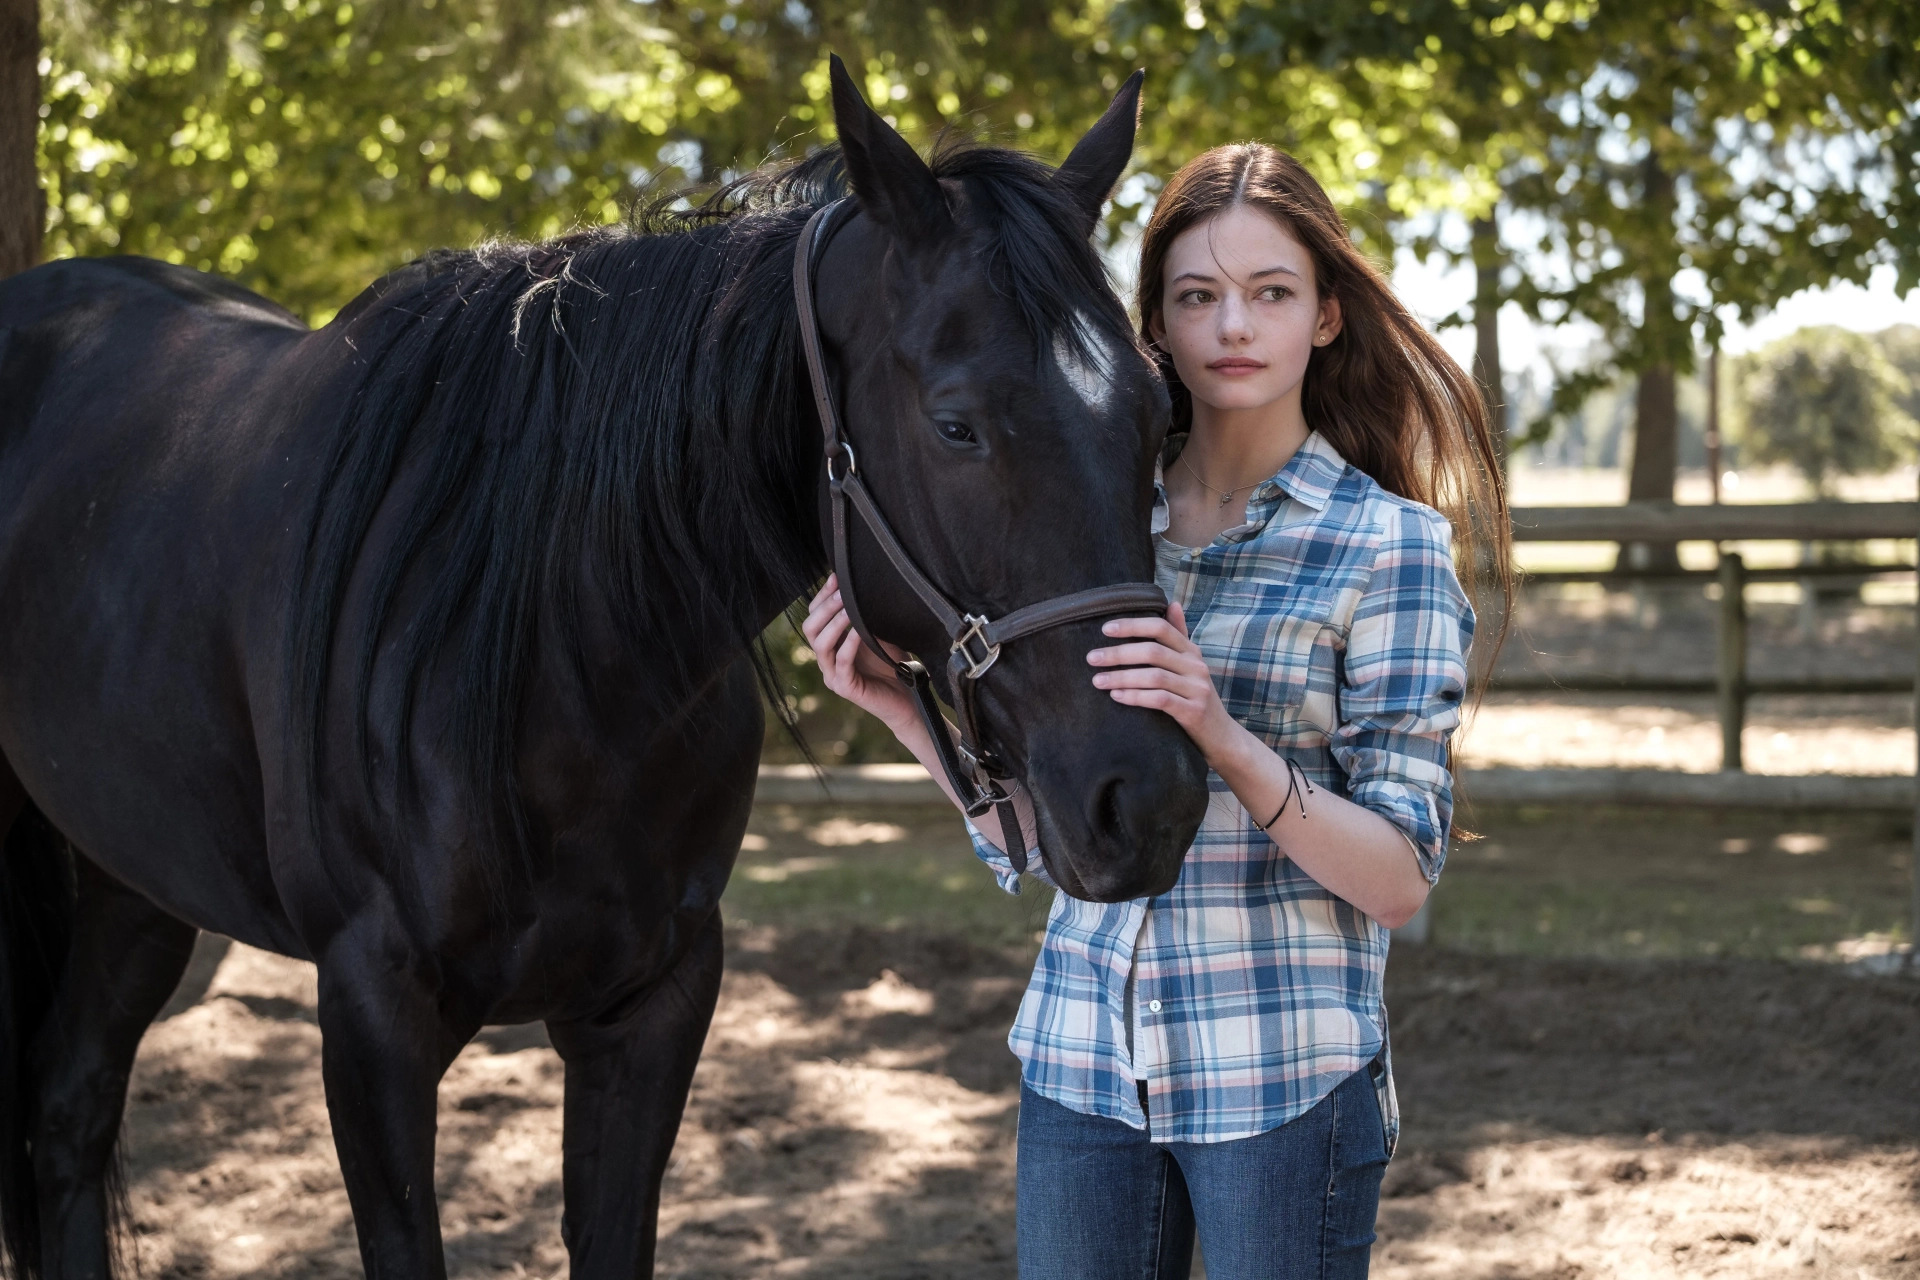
[319,921,480,1280]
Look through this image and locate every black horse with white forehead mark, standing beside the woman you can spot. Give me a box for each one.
[0,61,1206,1278]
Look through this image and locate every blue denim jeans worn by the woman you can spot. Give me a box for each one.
[1018,1069,1386,1280]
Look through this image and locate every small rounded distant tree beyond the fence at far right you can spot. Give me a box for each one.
[1734,328,1920,497]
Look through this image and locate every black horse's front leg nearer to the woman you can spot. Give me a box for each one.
[547,910,722,1280]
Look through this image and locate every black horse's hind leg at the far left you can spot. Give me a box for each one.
[33,856,200,1280]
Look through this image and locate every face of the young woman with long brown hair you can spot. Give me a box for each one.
[1152,205,1340,418]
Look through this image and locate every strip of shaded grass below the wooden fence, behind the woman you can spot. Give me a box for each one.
[726,804,1910,960]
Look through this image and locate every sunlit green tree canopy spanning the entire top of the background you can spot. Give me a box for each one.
[0,0,1920,759]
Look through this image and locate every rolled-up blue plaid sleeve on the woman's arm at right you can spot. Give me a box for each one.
[1332,505,1473,883]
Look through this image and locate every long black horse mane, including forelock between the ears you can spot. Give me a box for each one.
[288,140,1131,890]
